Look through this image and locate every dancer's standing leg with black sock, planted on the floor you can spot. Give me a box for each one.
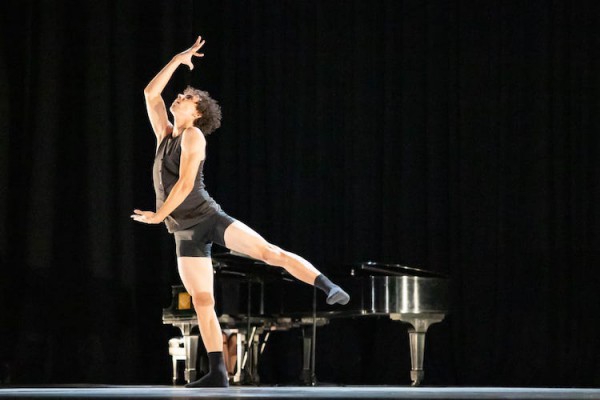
[177,257,229,387]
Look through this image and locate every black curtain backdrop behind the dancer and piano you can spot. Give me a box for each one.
[0,0,600,386]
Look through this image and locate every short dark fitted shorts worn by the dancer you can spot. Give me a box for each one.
[173,211,235,257]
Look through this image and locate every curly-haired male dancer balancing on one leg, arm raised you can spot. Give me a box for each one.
[131,37,350,387]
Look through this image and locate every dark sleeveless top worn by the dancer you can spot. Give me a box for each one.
[152,134,221,233]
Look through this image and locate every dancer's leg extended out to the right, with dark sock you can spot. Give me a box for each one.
[225,221,350,304]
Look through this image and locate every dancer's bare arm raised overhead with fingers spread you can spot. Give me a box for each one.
[144,36,205,143]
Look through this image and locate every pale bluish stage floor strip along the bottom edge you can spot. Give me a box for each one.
[0,385,600,400]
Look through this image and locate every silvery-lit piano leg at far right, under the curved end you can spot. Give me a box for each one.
[390,314,444,386]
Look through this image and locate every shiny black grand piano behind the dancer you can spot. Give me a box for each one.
[163,252,450,386]
